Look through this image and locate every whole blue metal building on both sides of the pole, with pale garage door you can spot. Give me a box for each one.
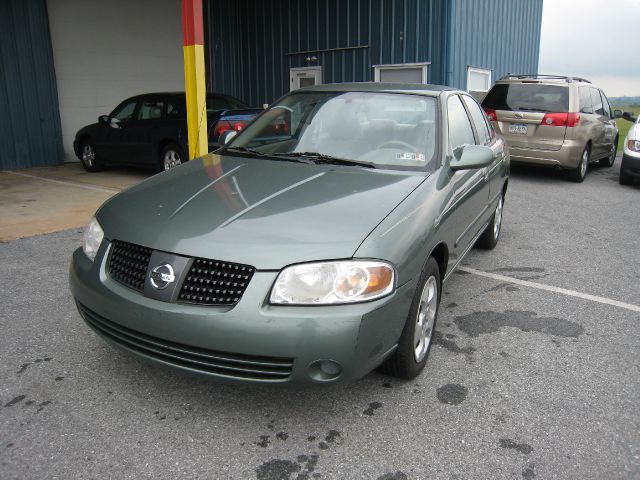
[0,0,543,170]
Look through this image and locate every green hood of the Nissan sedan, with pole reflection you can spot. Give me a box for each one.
[96,154,426,270]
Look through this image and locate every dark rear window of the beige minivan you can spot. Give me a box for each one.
[482,83,569,112]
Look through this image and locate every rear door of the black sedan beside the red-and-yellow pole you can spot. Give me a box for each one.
[122,95,165,166]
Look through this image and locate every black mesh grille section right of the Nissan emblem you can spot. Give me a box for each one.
[178,258,255,305]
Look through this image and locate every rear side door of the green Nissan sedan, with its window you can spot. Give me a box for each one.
[462,95,505,202]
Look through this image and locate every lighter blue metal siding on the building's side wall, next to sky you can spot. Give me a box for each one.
[444,0,542,89]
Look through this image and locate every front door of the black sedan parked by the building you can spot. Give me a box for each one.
[95,98,138,163]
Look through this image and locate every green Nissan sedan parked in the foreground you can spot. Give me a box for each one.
[70,83,510,384]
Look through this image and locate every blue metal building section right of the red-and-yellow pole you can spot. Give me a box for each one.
[205,0,542,105]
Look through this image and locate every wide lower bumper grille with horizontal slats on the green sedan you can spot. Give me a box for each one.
[76,302,293,381]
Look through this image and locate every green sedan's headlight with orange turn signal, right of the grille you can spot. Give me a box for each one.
[270,260,395,305]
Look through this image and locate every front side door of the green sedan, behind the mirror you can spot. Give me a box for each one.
[447,95,489,258]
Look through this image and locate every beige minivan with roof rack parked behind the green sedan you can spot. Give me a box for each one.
[482,74,622,182]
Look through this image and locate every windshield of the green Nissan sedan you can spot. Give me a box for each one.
[222,92,437,171]
